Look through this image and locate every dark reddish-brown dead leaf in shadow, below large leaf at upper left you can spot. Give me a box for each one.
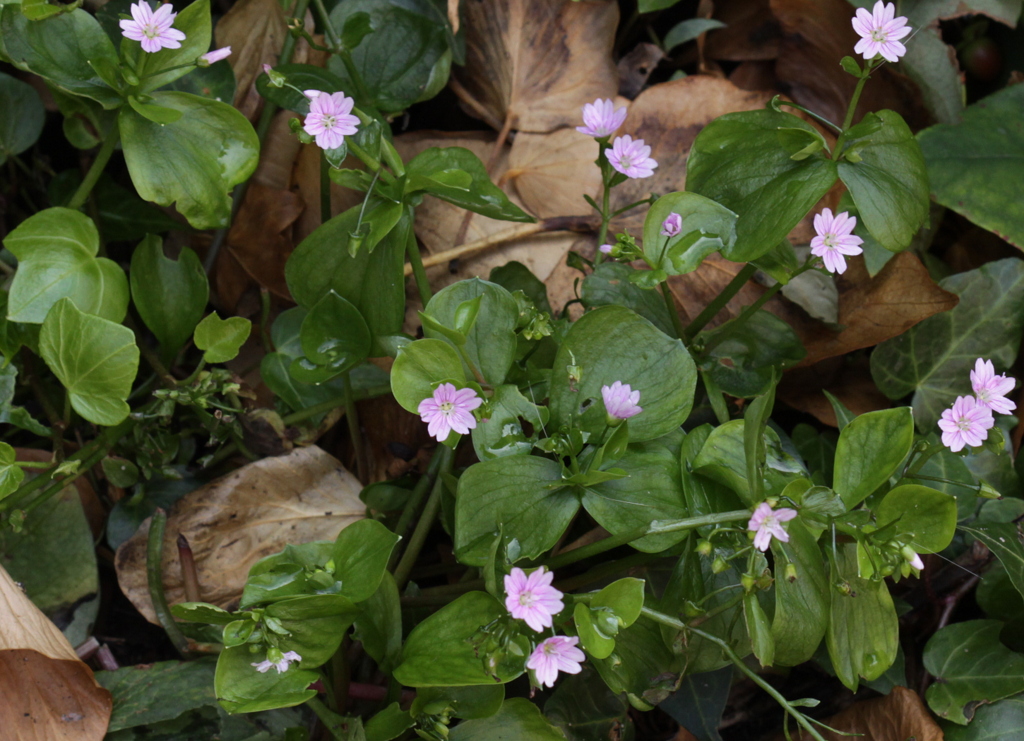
[227,182,305,301]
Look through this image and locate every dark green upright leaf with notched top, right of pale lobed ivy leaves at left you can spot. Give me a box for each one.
[129,234,210,358]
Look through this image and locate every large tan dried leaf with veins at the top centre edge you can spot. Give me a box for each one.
[454,0,618,132]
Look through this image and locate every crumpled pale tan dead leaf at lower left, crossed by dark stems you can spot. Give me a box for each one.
[115,445,366,622]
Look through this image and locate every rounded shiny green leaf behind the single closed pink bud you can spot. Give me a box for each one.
[643,191,736,275]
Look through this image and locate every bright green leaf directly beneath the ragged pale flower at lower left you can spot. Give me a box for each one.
[214,646,319,713]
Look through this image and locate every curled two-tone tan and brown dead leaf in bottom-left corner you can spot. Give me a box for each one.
[0,567,114,741]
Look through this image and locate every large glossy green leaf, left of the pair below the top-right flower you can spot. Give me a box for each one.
[686,110,837,262]
